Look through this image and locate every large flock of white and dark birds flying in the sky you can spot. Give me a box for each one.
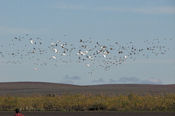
[0,34,172,71]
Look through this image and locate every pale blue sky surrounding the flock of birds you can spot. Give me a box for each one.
[0,0,175,85]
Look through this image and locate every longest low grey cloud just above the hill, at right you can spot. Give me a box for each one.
[109,77,162,84]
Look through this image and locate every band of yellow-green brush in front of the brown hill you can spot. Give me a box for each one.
[0,94,175,111]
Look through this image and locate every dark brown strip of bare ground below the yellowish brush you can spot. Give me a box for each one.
[0,112,175,116]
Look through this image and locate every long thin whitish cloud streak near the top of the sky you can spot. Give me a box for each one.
[56,3,175,14]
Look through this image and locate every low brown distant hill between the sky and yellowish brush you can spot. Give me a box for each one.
[0,82,175,96]
